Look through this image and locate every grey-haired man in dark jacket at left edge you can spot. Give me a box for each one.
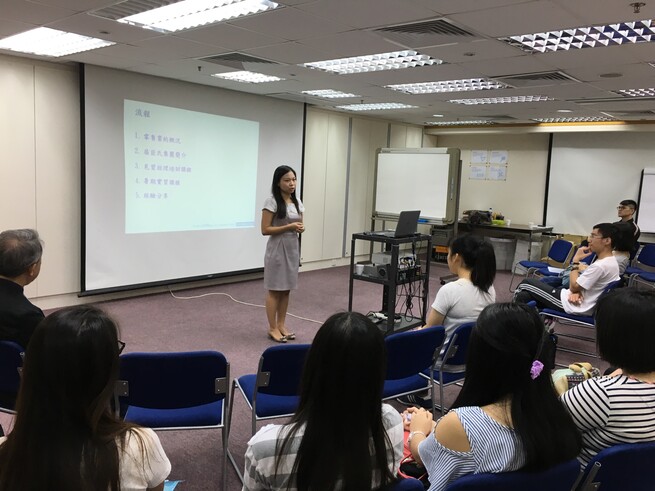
[0,229,44,348]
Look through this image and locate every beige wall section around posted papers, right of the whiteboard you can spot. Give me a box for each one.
[437,134,548,224]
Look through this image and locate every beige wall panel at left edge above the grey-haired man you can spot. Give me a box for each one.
[0,58,36,230]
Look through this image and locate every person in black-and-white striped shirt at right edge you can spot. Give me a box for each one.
[561,288,655,464]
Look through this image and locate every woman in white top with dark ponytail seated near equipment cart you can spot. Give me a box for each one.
[426,235,496,339]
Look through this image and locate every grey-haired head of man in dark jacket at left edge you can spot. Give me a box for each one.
[0,228,43,286]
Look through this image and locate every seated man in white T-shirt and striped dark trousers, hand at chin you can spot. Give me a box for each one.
[514,223,619,315]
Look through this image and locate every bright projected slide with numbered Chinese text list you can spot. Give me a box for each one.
[123,99,259,234]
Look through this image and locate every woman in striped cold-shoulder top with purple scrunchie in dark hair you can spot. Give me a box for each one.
[410,303,581,491]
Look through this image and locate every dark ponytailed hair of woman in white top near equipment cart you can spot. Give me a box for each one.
[449,235,496,293]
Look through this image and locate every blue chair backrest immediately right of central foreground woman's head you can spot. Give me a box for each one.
[384,326,446,380]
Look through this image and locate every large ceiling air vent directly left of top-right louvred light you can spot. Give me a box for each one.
[373,18,481,48]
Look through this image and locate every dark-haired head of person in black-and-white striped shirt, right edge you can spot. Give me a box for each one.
[596,288,655,374]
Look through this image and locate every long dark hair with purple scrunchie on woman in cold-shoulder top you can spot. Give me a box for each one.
[453,303,581,470]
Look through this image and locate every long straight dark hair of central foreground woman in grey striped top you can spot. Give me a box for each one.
[276,312,394,491]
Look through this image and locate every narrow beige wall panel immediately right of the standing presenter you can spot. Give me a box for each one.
[301,109,329,261]
